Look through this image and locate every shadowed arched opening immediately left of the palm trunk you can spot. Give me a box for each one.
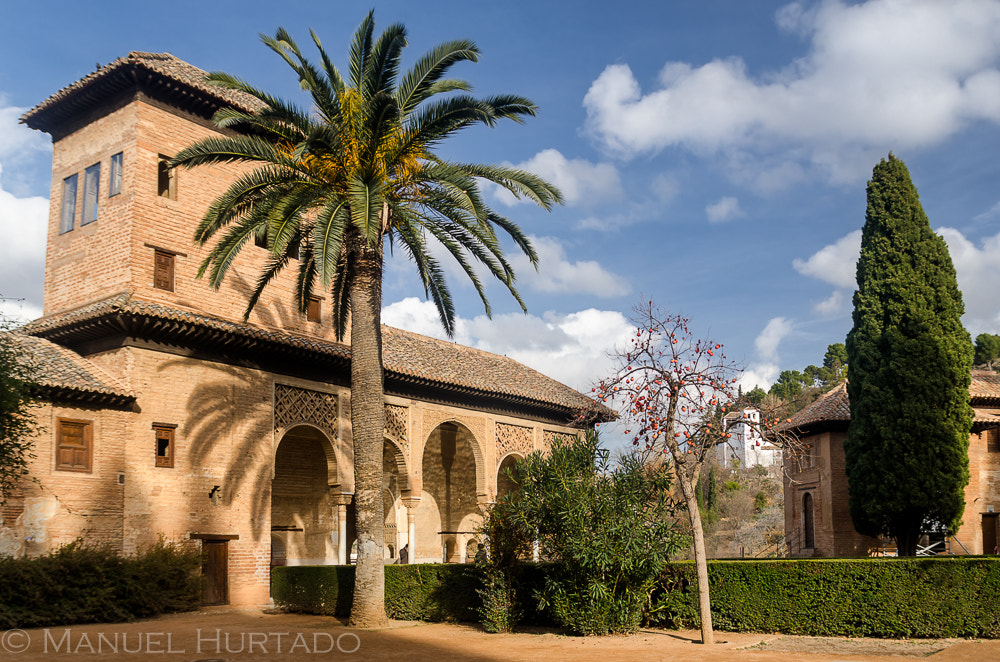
[271,425,337,565]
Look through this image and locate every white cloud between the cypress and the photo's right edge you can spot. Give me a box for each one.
[938,228,1000,337]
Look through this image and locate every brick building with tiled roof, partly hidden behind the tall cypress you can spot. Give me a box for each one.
[781,370,1000,557]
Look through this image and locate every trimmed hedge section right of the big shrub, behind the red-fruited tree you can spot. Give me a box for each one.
[648,557,1000,637]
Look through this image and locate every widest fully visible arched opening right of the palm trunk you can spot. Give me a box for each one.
[420,422,481,563]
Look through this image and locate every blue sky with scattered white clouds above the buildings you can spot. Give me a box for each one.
[0,0,1000,402]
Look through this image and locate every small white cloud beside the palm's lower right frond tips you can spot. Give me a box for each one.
[510,237,631,297]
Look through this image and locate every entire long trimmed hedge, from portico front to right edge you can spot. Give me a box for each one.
[273,557,1000,638]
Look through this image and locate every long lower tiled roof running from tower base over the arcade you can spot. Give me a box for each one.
[21,292,600,417]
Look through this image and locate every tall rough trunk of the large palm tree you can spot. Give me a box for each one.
[348,234,388,628]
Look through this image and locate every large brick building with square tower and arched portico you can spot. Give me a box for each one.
[0,52,600,605]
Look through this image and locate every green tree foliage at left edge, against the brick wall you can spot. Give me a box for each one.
[0,330,37,504]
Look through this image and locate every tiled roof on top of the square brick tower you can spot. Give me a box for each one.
[21,51,261,125]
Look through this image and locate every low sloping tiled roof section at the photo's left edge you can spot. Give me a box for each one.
[2,331,133,398]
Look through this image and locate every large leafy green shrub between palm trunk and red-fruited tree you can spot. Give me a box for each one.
[486,431,680,634]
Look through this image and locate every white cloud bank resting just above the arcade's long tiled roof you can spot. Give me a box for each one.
[382,297,635,392]
